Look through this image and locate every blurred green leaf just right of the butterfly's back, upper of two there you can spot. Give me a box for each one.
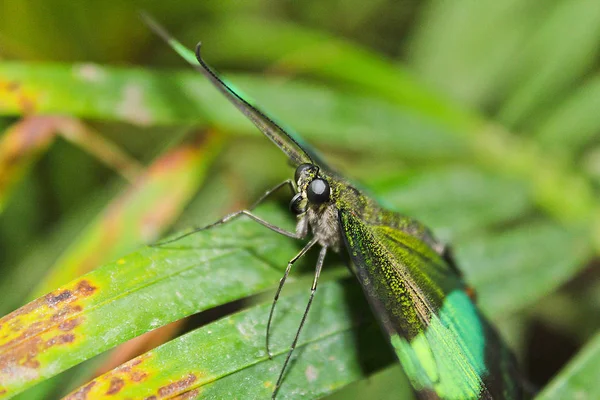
[373,166,533,241]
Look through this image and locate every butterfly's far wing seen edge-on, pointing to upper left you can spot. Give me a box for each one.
[142,14,326,168]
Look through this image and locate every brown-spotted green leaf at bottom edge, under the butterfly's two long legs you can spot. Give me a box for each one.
[66,280,398,399]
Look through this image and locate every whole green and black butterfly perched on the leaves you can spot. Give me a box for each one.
[144,16,526,399]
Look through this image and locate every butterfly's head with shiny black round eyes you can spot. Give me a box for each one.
[290,164,331,215]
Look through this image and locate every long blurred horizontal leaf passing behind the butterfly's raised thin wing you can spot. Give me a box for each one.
[0,63,465,159]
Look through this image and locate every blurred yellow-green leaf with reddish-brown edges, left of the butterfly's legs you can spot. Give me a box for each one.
[33,132,223,298]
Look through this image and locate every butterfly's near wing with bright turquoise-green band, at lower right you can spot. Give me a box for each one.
[339,209,522,399]
